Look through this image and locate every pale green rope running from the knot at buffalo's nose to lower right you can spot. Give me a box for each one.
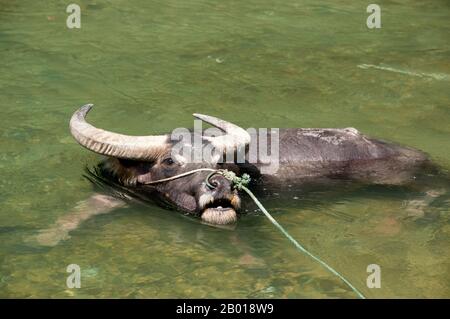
[218,170,366,299]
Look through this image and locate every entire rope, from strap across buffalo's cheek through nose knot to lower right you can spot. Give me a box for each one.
[145,168,366,299]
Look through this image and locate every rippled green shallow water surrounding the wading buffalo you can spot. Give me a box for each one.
[0,0,450,298]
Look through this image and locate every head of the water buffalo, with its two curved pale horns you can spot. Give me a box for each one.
[70,104,250,224]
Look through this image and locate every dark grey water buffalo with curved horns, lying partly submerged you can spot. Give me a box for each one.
[70,104,429,228]
